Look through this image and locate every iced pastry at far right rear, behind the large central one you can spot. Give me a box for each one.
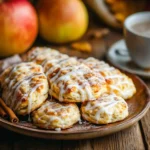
[81,57,136,99]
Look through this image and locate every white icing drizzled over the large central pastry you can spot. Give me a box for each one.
[47,64,105,101]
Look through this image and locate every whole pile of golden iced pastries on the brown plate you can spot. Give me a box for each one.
[0,47,136,130]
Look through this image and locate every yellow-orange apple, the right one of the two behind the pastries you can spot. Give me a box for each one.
[37,0,88,43]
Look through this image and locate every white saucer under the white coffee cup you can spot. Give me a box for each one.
[107,39,150,78]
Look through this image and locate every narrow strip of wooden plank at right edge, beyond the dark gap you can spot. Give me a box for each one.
[141,81,150,150]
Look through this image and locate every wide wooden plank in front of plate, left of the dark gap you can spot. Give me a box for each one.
[0,123,145,150]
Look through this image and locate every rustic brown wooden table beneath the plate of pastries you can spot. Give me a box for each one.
[0,13,150,150]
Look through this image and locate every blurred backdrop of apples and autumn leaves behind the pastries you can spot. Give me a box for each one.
[0,0,150,58]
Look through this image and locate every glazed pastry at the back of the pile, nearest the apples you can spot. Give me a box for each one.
[25,47,69,66]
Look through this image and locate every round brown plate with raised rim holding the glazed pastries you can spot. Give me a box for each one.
[0,74,150,140]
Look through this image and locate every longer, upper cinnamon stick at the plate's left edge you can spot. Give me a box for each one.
[0,98,19,123]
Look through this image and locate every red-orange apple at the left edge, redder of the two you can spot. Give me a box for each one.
[0,0,38,57]
